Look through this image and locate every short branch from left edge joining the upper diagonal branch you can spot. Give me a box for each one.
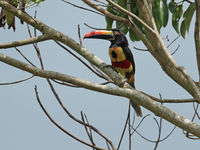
[0,34,50,49]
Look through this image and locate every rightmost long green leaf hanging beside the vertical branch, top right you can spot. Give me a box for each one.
[180,3,196,38]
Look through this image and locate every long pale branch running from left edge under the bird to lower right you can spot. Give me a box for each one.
[0,54,200,137]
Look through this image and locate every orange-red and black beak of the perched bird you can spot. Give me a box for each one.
[83,30,115,40]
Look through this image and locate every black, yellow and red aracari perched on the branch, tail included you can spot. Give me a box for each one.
[84,29,142,117]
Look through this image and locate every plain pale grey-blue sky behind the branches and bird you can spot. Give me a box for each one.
[0,0,199,150]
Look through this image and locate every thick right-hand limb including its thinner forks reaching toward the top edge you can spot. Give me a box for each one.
[82,0,200,103]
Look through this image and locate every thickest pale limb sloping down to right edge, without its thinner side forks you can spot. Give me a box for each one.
[136,0,200,102]
